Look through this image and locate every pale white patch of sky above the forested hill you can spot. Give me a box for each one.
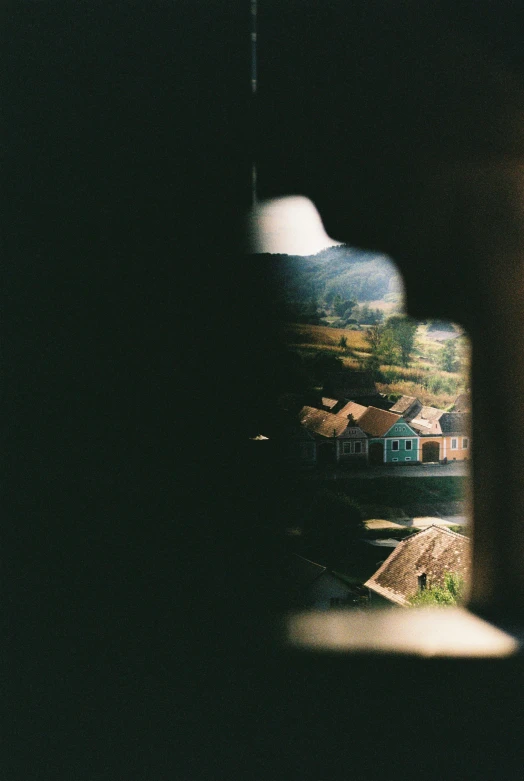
[250,195,340,255]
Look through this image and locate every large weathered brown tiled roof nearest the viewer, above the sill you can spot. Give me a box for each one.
[364,526,470,605]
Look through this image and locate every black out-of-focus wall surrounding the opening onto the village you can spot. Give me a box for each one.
[6,0,524,781]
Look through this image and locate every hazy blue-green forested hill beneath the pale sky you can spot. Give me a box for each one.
[252,244,402,304]
